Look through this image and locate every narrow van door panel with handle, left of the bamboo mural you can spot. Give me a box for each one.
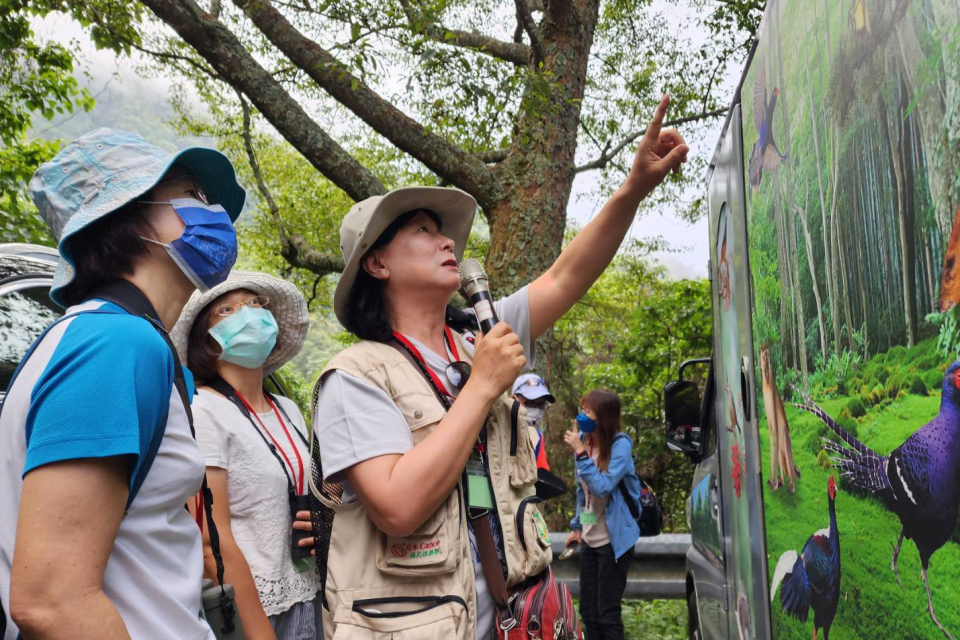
[708,105,769,638]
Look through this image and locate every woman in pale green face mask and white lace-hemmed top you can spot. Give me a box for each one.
[171,271,320,640]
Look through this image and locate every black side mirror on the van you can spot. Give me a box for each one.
[663,358,712,462]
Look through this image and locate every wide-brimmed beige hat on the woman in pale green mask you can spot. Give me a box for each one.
[170,271,310,375]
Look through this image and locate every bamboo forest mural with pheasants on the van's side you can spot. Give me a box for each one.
[744,0,960,640]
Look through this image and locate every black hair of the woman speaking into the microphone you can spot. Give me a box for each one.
[345,209,443,343]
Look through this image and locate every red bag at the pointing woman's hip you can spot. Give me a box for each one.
[497,567,583,640]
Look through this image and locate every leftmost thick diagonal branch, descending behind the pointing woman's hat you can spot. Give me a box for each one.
[143,0,386,200]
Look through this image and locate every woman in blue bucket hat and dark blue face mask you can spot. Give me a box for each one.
[0,129,245,640]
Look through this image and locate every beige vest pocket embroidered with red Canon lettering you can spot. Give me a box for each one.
[377,490,462,576]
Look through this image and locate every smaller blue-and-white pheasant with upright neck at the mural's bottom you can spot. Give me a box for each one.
[770,476,840,640]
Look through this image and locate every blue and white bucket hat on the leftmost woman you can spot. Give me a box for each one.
[30,128,247,306]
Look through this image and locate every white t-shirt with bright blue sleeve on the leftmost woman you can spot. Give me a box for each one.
[0,301,214,640]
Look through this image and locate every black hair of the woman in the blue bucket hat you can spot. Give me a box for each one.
[60,202,156,306]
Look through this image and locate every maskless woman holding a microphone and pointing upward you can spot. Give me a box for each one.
[311,92,689,640]
